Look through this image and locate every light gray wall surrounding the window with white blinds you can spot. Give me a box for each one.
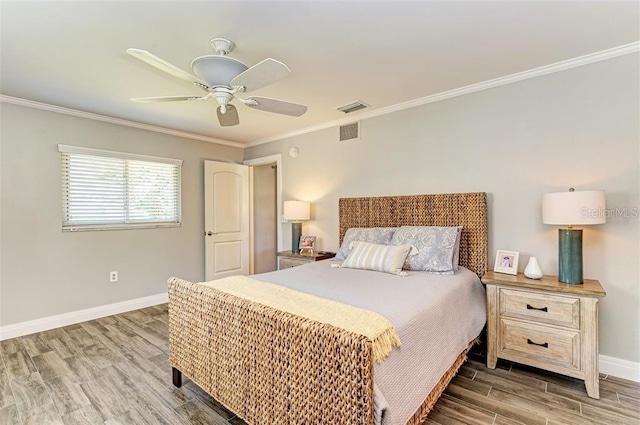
[0,103,242,326]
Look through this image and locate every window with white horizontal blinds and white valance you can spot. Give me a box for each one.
[58,145,182,231]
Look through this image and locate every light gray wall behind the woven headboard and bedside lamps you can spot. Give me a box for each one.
[245,54,640,362]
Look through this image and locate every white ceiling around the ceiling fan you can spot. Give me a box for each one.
[0,0,640,144]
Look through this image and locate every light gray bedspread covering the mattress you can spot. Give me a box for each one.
[254,260,487,425]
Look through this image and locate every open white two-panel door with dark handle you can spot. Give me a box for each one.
[204,161,250,281]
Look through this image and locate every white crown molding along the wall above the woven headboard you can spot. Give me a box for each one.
[245,41,640,148]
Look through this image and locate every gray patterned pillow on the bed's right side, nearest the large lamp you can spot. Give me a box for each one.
[391,226,458,274]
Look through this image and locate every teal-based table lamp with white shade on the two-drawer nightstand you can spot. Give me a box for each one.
[542,188,607,284]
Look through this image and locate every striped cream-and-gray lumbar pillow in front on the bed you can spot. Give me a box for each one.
[342,241,411,276]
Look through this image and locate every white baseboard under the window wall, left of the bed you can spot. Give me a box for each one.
[0,292,169,341]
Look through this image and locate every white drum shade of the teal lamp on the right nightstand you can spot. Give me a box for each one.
[542,190,607,226]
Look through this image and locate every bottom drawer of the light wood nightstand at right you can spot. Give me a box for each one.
[498,319,580,372]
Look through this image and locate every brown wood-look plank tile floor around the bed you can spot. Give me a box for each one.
[0,304,640,425]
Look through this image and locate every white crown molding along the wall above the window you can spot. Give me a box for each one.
[0,94,245,149]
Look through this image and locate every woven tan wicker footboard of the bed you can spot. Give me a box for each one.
[169,278,373,425]
